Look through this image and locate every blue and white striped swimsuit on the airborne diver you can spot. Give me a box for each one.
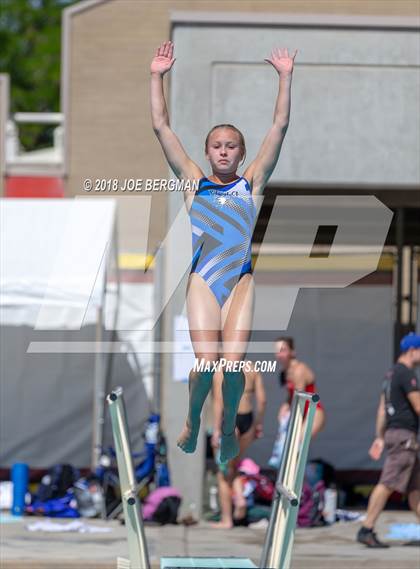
[189,178,256,306]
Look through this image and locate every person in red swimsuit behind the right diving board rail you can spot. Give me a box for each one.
[275,336,325,438]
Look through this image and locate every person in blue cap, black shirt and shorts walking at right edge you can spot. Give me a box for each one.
[357,333,420,547]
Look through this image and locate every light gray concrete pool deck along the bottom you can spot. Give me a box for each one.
[0,512,420,569]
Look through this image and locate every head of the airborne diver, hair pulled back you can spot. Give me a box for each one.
[206,128,243,174]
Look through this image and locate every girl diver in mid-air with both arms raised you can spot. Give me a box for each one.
[150,41,297,462]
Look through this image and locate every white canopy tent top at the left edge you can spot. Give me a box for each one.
[0,199,115,324]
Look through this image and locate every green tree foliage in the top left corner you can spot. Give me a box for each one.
[0,0,75,150]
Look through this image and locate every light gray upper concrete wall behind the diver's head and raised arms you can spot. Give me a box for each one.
[171,15,420,187]
